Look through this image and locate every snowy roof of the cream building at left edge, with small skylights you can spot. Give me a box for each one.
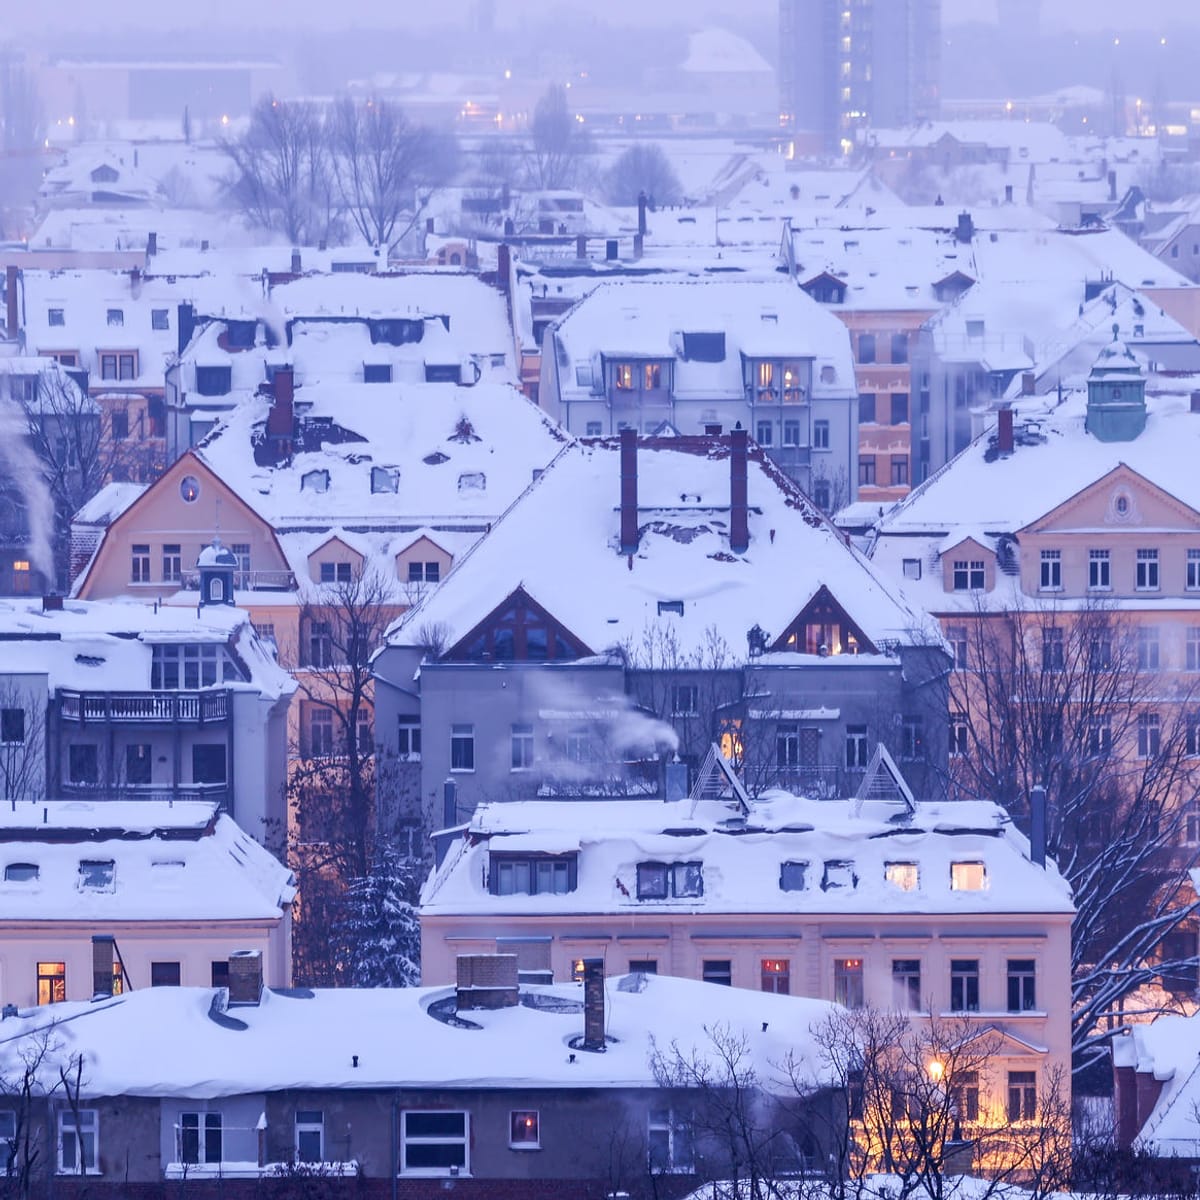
[0,800,295,926]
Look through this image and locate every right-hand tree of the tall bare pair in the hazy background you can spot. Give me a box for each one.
[330,96,457,246]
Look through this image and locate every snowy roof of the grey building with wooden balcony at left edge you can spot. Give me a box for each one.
[0,598,295,698]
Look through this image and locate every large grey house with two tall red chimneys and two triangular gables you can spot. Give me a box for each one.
[374,430,947,849]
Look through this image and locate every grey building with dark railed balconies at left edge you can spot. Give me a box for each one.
[0,595,295,841]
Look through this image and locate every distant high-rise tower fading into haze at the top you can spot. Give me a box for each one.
[779,0,942,152]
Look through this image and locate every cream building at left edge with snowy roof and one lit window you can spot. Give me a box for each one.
[0,799,295,1008]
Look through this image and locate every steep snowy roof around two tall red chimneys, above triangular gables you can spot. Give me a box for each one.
[391,438,936,661]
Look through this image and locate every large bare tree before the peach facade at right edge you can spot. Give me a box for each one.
[950,604,1200,1070]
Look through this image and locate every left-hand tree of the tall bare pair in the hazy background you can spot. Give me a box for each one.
[222,96,341,245]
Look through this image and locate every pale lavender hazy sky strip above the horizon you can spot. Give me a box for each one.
[9,0,1200,34]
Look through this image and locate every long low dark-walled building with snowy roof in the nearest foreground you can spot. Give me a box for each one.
[0,969,832,1200]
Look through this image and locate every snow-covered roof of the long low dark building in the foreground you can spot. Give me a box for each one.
[0,976,835,1099]
